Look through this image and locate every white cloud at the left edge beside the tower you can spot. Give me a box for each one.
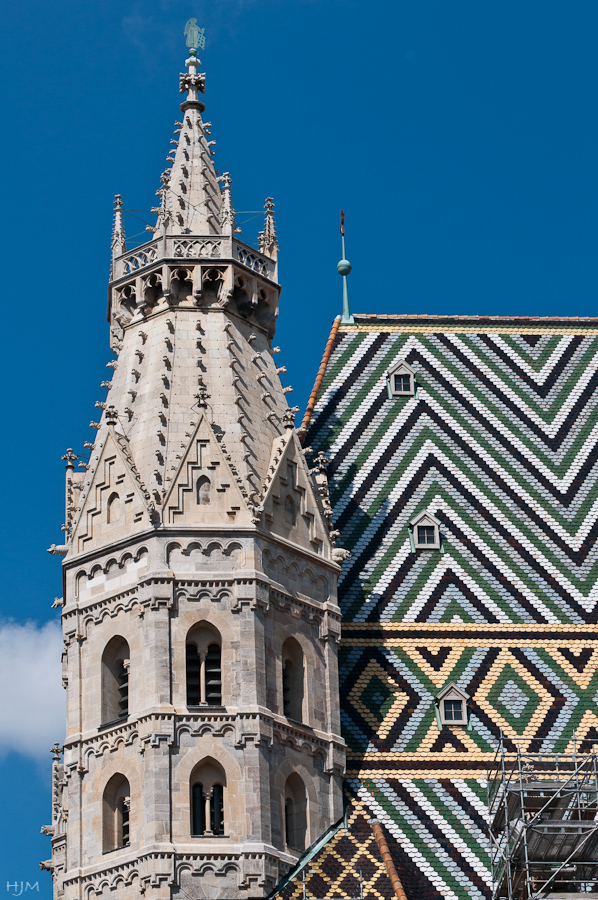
[0,621,65,759]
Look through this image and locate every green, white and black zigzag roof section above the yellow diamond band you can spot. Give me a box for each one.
[306,328,598,624]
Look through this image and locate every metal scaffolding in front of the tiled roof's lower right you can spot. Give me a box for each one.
[488,741,598,900]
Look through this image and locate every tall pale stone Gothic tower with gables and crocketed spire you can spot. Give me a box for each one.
[44,44,344,900]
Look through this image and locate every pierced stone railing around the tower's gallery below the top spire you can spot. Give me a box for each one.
[112,234,276,281]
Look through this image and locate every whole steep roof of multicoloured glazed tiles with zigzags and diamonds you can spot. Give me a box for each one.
[305,316,598,900]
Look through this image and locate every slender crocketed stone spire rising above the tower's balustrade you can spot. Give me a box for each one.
[150,47,222,235]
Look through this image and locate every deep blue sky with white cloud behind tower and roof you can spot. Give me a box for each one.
[0,0,598,897]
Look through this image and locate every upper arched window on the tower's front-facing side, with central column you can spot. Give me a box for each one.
[185,622,222,706]
